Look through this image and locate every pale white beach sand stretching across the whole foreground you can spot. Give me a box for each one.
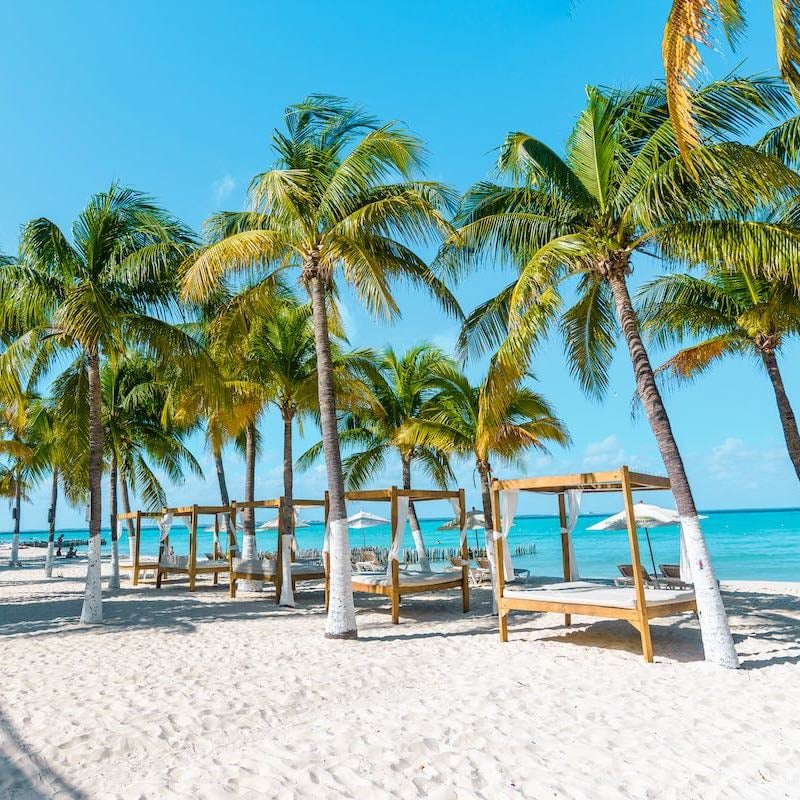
[0,551,800,800]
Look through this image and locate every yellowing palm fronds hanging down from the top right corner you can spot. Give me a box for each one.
[662,0,800,164]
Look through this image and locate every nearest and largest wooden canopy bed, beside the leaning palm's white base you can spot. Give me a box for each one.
[492,466,697,662]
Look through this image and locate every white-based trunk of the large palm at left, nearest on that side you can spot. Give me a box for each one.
[81,347,103,625]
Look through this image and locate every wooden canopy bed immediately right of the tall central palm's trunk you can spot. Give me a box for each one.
[345,486,469,625]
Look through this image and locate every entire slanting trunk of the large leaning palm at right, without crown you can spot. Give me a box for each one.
[607,266,739,669]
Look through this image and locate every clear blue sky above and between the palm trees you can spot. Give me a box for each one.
[0,0,800,529]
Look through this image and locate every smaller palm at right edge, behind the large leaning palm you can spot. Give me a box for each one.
[638,269,800,479]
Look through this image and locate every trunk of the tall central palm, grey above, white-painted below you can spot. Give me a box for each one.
[306,264,358,639]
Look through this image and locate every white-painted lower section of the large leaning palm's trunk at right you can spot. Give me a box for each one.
[681,517,739,669]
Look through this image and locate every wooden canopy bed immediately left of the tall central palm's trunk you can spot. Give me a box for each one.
[230,492,328,608]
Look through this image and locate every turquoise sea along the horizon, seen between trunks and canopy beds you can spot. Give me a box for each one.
[0,509,800,581]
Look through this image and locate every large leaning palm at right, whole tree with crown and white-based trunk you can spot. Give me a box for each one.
[442,81,800,667]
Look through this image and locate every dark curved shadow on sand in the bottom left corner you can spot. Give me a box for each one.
[0,708,89,800]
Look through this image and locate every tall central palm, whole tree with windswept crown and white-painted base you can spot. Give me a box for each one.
[184,96,458,638]
